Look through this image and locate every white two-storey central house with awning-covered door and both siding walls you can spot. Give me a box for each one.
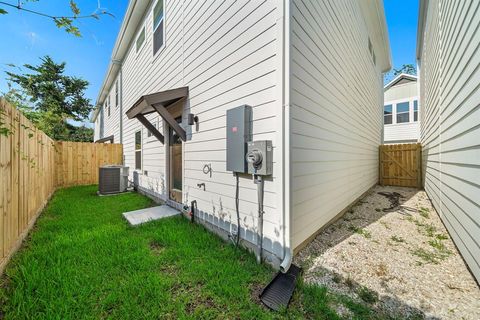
[93,0,390,268]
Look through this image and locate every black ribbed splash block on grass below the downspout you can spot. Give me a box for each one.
[260,264,302,311]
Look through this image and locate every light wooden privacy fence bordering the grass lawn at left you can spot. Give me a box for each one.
[0,99,123,273]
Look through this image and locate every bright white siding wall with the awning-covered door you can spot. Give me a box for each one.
[101,0,283,255]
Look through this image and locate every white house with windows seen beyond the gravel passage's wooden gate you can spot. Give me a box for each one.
[383,73,420,144]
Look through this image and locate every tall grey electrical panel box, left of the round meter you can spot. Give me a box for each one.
[227,105,252,173]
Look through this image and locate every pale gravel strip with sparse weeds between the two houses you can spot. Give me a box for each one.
[295,186,480,319]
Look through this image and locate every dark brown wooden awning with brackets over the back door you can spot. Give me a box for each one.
[126,87,188,143]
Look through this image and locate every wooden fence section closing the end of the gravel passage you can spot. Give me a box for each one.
[379,143,422,188]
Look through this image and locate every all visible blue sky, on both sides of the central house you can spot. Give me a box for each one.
[0,0,418,125]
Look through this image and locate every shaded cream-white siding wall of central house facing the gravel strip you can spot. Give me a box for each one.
[290,0,383,248]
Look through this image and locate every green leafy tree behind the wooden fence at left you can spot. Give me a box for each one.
[5,56,93,141]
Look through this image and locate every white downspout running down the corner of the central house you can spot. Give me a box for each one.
[280,0,293,273]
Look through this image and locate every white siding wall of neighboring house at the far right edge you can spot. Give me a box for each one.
[417,0,480,281]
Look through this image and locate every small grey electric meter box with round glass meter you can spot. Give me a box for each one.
[246,140,273,176]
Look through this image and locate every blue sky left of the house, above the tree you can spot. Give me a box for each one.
[0,0,128,116]
